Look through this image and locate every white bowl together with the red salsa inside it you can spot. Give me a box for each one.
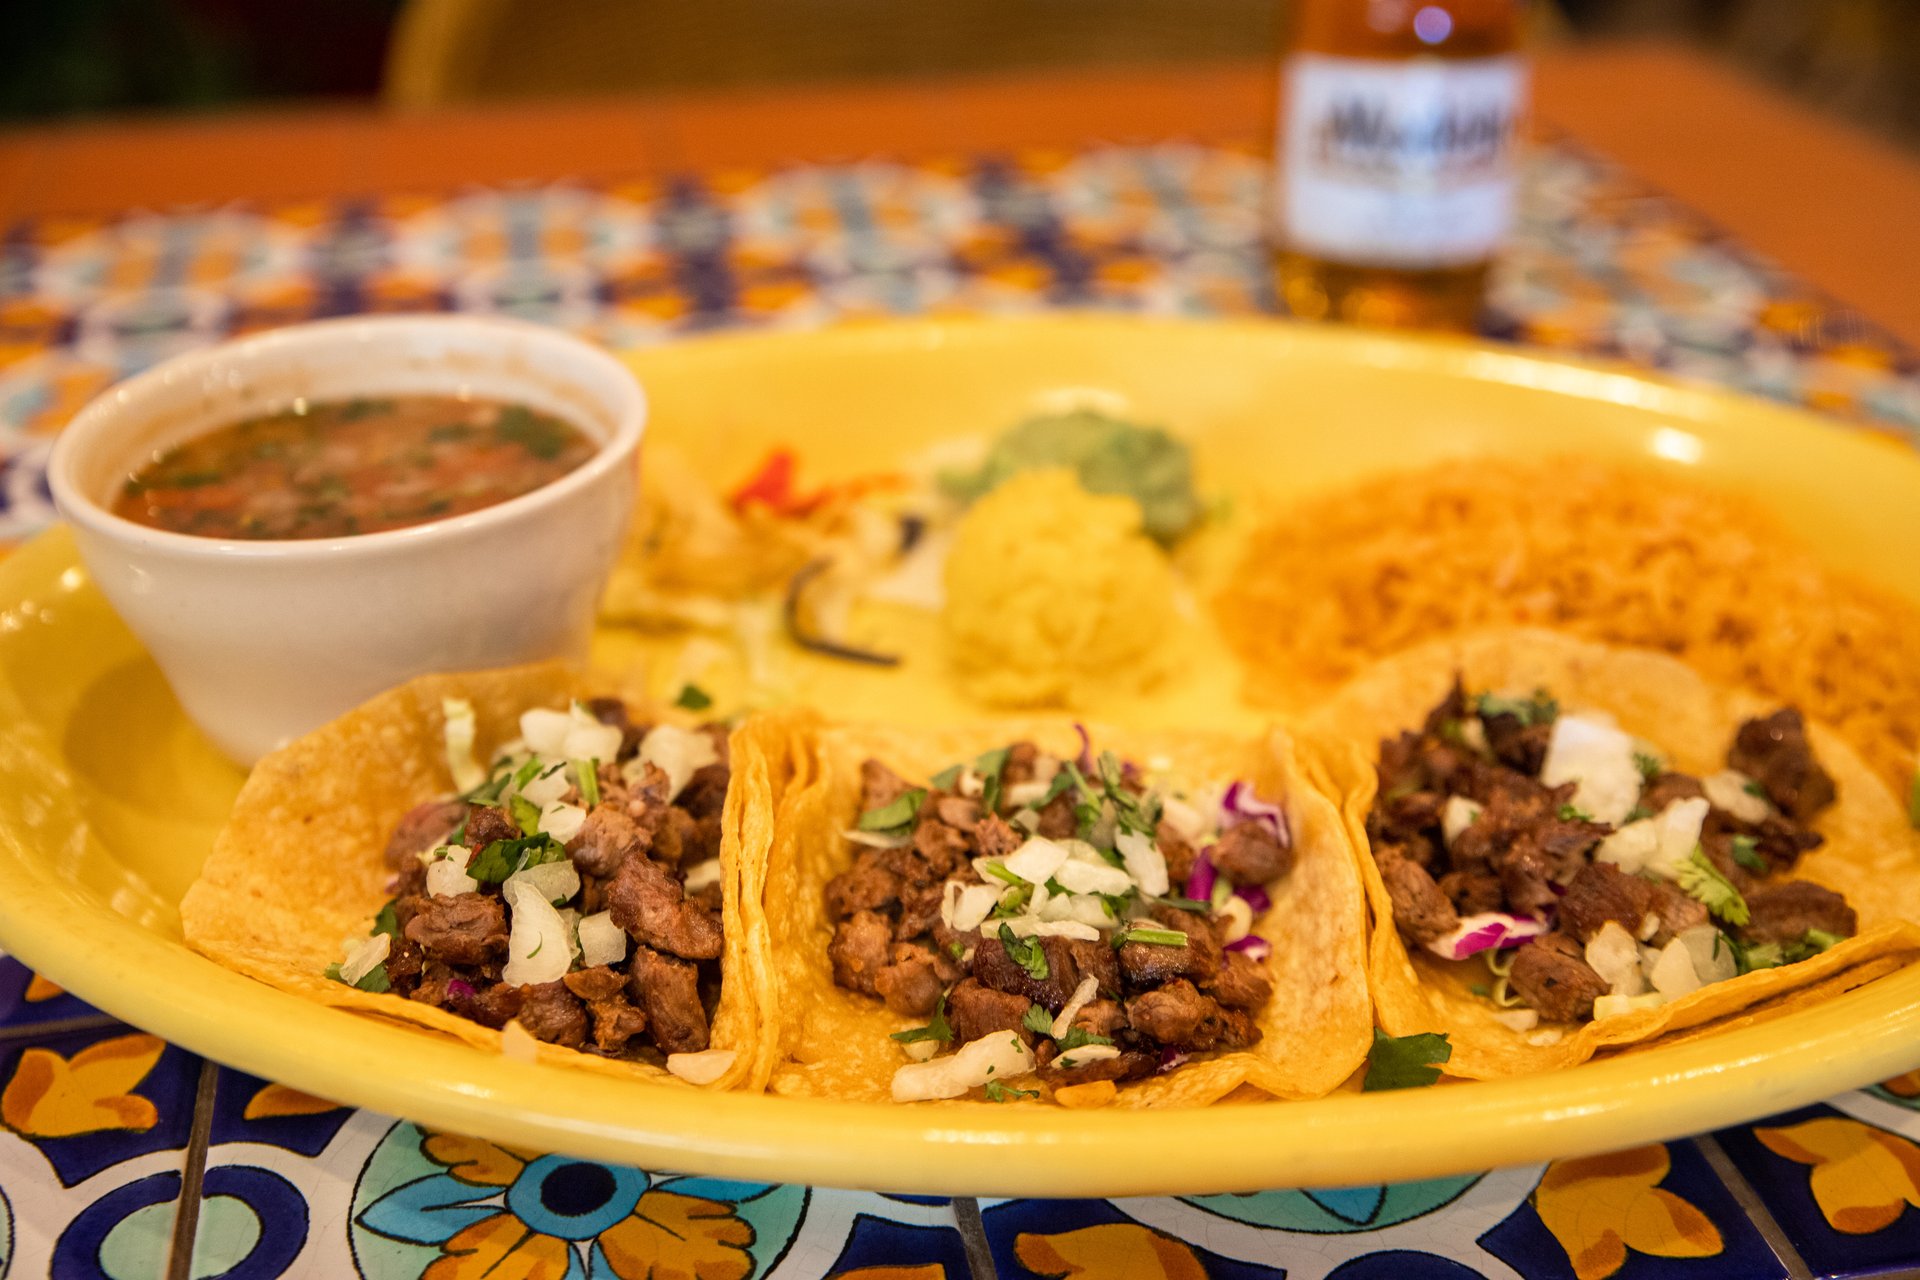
[48,315,645,762]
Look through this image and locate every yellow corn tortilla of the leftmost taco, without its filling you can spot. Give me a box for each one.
[180,664,787,1088]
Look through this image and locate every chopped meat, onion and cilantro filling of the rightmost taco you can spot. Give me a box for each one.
[1367,679,1857,1031]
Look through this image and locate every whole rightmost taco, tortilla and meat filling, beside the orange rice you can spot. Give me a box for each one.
[1313,629,1920,1079]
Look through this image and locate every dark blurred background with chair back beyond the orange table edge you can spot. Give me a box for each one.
[11,0,1920,146]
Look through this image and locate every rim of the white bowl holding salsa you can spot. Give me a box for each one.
[46,311,647,560]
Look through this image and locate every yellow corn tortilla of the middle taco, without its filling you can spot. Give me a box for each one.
[747,722,1373,1107]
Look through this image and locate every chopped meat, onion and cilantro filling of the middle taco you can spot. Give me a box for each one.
[826,741,1294,1102]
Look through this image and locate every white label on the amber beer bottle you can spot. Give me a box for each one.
[1279,54,1524,267]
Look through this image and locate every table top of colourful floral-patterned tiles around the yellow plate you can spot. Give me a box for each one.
[0,135,1920,1280]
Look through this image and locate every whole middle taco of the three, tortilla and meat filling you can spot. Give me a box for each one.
[764,723,1371,1107]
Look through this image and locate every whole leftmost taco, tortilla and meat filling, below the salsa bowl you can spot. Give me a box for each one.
[180,666,785,1086]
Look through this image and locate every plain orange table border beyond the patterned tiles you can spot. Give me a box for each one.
[0,44,1920,345]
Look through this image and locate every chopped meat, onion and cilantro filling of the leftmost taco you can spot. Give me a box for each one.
[328,699,730,1082]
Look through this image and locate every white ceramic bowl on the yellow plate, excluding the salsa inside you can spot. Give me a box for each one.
[48,315,647,764]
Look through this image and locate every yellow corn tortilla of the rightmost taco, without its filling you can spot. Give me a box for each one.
[1309,628,1920,1079]
